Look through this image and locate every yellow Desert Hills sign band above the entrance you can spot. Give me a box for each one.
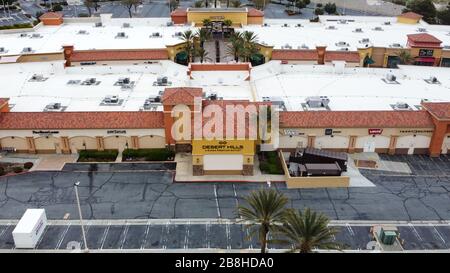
[192,140,255,155]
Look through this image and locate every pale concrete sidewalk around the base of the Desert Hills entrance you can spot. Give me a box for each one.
[175,153,285,183]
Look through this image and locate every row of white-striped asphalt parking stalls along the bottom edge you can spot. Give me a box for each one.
[0,222,450,250]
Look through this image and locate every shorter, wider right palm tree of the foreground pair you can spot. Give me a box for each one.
[279,208,343,253]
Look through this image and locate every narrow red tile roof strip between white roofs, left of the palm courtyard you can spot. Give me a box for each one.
[70,49,169,62]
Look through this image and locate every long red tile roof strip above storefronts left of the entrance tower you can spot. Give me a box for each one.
[0,112,164,130]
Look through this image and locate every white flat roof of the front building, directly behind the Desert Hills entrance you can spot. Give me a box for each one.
[0,61,450,112]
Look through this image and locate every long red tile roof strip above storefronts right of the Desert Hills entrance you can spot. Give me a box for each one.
[280,111,433,128]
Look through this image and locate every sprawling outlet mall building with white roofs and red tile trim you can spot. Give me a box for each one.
[0,9,450,175]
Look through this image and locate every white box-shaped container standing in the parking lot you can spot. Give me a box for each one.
[12,209,47,248]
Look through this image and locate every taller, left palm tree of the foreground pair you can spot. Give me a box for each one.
[238,189,288,253]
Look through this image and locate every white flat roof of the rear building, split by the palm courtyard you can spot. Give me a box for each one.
[0,16,450,56]
